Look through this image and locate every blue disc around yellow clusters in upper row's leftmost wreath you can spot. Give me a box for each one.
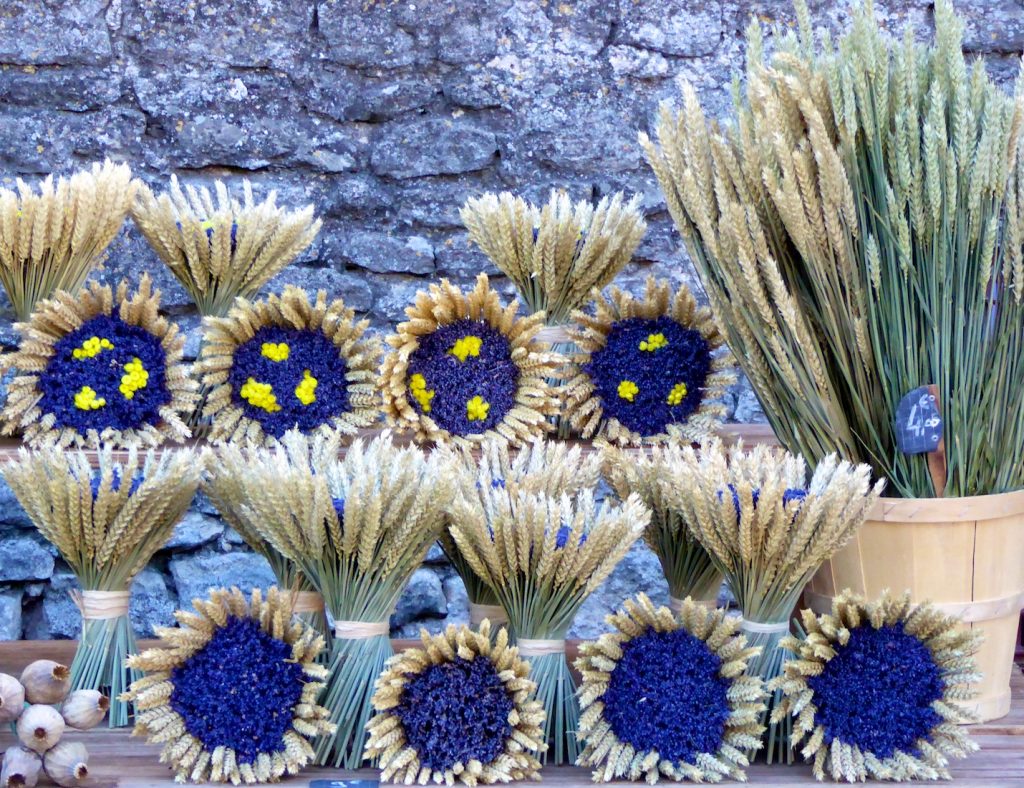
[39,315,171,433]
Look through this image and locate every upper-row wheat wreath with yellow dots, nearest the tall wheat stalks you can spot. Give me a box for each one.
[565,277,736,445]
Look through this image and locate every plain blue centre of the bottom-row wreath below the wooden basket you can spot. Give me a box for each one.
[807,623,944,758]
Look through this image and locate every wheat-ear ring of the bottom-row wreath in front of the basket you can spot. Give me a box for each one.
[769,592,981,783]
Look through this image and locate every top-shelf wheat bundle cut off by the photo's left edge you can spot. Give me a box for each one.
[0,161,138,322]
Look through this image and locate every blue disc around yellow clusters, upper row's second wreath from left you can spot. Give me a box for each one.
[227,325,349,438]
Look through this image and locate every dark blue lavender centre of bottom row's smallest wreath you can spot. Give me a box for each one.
[394,656,513,772]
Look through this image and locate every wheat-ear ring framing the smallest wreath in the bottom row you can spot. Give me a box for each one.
[366,620,544,786]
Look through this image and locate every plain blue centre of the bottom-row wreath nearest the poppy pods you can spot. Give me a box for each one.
[170,616,304,763]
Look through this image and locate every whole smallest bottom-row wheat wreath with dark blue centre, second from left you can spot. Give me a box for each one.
[367,620,544,786]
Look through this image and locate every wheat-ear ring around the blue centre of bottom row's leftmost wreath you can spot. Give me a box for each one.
[124,587,334,785]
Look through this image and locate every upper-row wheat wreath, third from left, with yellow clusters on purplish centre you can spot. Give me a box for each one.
[381,273,562,445]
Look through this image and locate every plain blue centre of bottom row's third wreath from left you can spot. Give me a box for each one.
[603,629,730,763]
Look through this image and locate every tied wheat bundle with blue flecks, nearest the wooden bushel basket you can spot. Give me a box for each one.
[664,441,885,763]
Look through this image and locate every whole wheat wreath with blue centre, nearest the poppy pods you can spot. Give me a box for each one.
[125,587,334,785]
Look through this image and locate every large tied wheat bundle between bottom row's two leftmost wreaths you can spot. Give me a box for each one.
[207,425,455,769]
